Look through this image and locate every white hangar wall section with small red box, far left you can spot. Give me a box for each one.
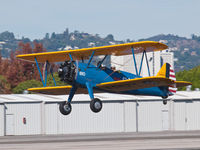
[5,102,41,135]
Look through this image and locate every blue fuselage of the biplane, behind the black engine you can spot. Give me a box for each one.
[75,62,168,97]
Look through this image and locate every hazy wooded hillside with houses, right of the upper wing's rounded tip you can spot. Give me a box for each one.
[140,34,200,71]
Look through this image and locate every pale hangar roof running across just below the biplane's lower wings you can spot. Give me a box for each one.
[0,91,200,103]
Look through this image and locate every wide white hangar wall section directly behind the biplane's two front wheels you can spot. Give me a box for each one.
[45,101,124,134]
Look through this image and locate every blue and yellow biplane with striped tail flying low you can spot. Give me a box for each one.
[17,41,191,115]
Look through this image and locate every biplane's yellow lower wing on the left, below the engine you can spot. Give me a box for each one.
[28,86,87,95]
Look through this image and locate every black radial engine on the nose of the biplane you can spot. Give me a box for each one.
[58,61,76,84]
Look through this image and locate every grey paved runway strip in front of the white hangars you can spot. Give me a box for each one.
[0,131,200,150]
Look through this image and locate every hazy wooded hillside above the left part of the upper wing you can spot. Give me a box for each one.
[0,29,123,57]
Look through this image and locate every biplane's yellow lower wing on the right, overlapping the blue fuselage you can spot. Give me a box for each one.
[96,77,174,92]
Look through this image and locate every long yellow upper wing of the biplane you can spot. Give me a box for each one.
[17,41,168,62]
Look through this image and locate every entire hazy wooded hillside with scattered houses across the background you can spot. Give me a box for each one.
[0,29,200,72]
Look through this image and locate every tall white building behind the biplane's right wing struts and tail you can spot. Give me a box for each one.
[111,51,174,77]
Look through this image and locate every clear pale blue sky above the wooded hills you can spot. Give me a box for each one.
[0,0,200,40]
